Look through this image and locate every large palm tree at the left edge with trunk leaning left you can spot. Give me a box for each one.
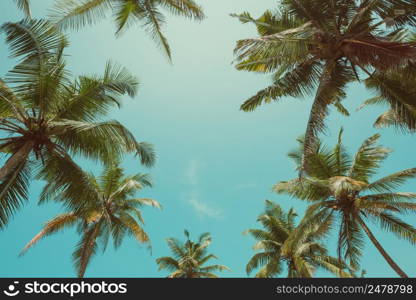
[0,19,155,228]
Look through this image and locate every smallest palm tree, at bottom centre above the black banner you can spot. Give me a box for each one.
[156,230,230,278]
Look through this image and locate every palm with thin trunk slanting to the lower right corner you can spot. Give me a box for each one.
[274,130,416,277]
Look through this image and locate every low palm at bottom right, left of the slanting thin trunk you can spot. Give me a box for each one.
[245,201,351,278]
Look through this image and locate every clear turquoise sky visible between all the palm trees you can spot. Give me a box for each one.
[0,0,416,277]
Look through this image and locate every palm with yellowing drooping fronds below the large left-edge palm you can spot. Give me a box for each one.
[21,163,161,277]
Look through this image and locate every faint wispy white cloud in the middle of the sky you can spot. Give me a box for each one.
[185,159,223,219]
